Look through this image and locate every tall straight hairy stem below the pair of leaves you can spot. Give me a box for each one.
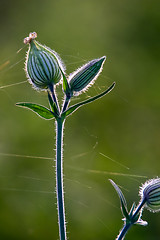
[56,118,67,240]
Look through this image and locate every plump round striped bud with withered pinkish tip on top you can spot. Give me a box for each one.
[24,32,64,90]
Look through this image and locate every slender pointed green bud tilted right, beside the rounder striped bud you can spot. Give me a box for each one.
[69,56,106,95]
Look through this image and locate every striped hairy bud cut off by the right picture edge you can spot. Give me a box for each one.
[139,178,160,212]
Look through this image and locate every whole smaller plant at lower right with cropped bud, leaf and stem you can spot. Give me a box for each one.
[110,177,160,240]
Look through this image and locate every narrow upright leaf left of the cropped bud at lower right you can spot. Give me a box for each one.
[109,179,130,220]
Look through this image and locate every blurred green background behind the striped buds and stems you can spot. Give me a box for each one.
[0,0,160,240]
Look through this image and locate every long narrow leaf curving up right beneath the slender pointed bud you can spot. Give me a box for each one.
[62,82,115,117]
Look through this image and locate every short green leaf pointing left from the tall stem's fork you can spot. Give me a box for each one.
[16,103,54,120]
